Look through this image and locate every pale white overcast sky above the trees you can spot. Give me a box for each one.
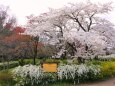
[0,0,115,25]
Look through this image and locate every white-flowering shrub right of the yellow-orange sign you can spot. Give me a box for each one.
[58,64,101,83]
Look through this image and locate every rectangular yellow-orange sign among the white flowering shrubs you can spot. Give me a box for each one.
[42,63,58,72]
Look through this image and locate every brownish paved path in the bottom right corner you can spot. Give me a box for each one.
[75,78,115,86]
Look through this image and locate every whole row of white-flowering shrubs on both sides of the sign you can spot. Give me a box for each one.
[13,64,100,86]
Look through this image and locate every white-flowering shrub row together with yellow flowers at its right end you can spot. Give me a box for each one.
[3,60,115,86]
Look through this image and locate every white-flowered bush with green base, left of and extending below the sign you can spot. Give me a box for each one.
[13,65,54,86]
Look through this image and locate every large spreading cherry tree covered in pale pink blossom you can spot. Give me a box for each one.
[25,1,115,61]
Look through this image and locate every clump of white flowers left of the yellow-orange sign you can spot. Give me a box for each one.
[12,65,43,86]
